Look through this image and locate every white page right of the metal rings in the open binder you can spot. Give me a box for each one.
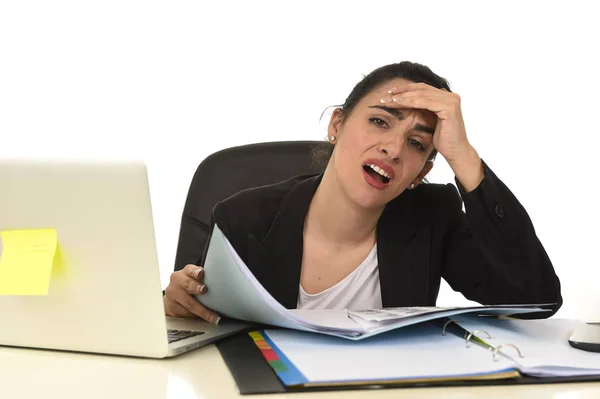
[453,316,600,377]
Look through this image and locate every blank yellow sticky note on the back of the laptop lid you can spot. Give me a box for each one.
[0,229,58,295]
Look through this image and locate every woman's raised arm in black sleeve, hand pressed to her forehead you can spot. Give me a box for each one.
[382,83,562,311]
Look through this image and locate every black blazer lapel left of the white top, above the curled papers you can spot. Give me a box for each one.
[248,175,322,309]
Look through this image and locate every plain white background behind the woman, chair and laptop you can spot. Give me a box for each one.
[0,0,600,321]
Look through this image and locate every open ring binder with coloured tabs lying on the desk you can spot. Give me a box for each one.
[238,316,600,396]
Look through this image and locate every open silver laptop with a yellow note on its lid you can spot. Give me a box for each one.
[0,159,249,358]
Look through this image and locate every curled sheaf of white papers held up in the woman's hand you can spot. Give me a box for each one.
[196,225,552,340]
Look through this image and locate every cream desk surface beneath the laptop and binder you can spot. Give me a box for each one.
[0,345,600,399]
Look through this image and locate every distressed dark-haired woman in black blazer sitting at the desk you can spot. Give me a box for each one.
[165,62,562,322]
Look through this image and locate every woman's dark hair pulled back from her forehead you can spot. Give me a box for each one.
[313,61,451,169]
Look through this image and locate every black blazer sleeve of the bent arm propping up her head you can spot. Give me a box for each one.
[442,161,562,316]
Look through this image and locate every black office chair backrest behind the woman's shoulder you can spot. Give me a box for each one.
[175,141,322,271]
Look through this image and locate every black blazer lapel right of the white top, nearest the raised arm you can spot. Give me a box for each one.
[377,193,431,307]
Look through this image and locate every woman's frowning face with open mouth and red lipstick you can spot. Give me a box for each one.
[328,79,437,208]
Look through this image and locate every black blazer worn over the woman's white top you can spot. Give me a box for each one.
[199,162,562,316]
